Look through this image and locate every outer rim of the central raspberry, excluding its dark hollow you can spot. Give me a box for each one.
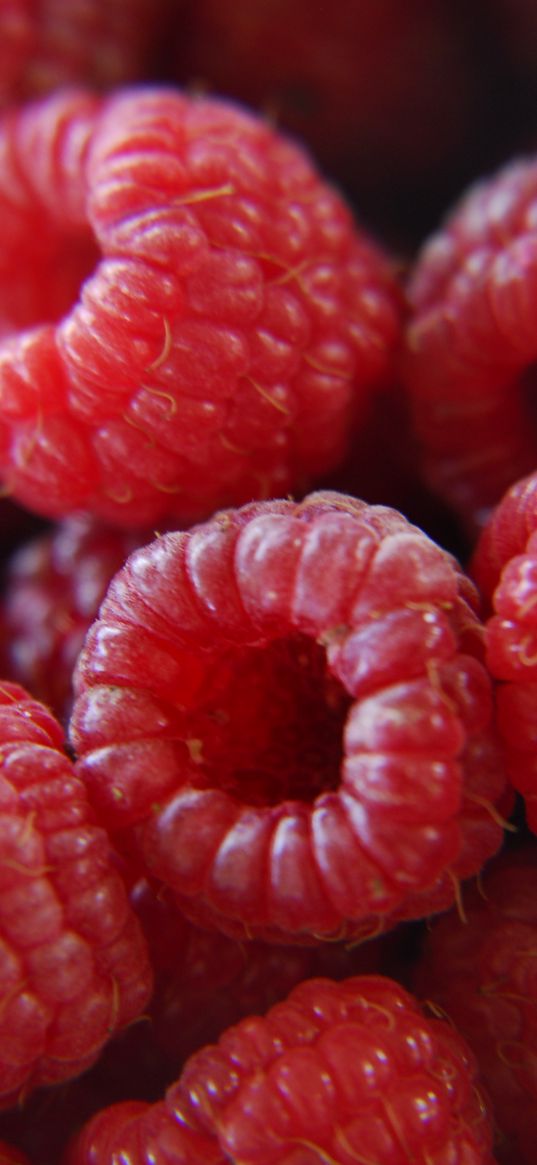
[70,493,503,940]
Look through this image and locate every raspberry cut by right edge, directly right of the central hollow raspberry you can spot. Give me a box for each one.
[472,474,537,833]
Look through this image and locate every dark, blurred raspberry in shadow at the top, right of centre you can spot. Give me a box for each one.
[176,0,480,199]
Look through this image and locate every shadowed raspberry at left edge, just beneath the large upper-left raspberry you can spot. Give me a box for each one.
[2,515,150,720]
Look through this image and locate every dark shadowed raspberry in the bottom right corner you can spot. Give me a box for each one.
[415,843,537,1165]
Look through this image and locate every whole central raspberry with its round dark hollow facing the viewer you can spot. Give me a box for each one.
[71,492,504,941]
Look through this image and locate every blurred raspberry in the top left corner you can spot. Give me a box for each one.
[0,0,163,107]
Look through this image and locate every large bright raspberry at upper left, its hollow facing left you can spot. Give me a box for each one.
[0,89,401,527]
